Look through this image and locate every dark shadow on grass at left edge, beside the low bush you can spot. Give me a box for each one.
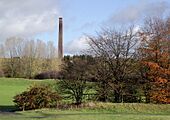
[0,105,18,113]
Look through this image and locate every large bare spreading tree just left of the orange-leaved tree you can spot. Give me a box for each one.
[88,27,137,102]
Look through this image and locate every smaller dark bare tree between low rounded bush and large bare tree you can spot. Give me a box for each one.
[59,56,93,105]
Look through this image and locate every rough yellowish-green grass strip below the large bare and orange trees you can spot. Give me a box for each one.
[85,102,170,115]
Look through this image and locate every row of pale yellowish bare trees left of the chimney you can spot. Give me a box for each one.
[0,37,60,78]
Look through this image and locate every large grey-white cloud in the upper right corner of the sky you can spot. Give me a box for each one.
[108,0,170,23]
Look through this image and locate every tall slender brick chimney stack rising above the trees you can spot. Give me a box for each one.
[58,17,63,59]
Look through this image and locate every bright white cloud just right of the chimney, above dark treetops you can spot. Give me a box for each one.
[64,36,88,54]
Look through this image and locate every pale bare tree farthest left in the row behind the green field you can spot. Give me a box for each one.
[3,37,24,77]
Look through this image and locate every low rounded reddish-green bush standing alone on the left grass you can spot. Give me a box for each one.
[13,86,61,110]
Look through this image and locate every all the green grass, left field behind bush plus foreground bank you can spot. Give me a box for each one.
[0,78,170,120]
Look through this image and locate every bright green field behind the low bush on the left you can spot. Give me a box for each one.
[0,78,54,106]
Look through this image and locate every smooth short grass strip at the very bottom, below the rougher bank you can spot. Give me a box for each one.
[0,109,170,120]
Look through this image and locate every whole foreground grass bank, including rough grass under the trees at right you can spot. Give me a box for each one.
[0,103,170,120]
